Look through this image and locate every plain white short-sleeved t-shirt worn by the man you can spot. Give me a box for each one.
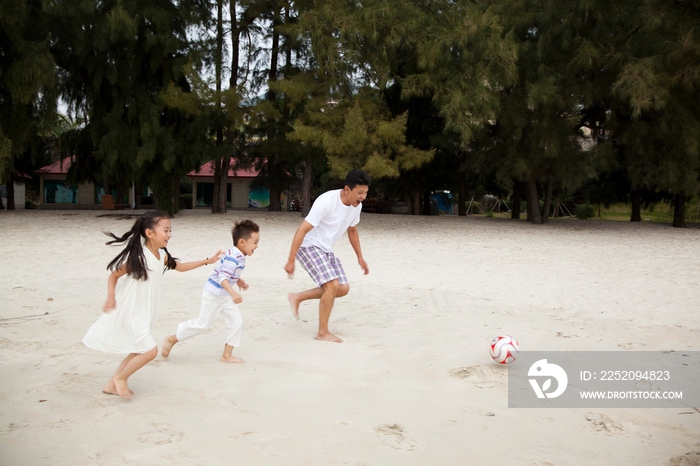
[301,189,362,252]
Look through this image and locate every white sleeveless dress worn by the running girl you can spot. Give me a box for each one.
[83,247,166,354]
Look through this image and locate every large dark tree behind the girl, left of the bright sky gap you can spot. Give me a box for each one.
[50,0,209,214]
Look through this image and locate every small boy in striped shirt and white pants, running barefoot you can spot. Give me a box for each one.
[161,220,260,363]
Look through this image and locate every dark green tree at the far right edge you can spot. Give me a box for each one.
[613,0,700,227]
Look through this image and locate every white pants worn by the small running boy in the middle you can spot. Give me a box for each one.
[175,290,243,347]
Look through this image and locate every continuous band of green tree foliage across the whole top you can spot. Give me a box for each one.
[0,0,700,224]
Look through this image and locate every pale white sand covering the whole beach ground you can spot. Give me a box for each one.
[0,210,700,466]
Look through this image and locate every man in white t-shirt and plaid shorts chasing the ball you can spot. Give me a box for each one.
[284,170,370,343]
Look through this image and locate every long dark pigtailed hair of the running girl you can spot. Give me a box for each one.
[103,210,177,280]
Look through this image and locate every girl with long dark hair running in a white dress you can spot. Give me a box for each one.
[83,212,222,398]
